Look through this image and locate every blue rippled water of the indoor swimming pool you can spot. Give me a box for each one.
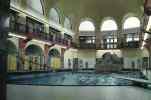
[8,71,144,86]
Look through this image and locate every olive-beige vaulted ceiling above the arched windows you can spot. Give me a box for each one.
[21,0,144,31]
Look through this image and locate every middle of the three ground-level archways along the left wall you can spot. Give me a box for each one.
[24,44,44,71]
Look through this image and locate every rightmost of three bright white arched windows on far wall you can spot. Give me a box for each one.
[123,17,140,29]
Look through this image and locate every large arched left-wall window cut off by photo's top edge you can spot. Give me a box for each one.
[26,0,43,16]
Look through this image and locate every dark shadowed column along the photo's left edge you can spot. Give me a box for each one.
[0,0,10,100]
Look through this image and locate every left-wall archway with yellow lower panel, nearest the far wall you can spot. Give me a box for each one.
[48,49,61,70]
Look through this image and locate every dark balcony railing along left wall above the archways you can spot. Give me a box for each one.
[10,23,71,46]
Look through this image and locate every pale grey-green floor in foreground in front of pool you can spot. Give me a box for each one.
[7,85,151,100]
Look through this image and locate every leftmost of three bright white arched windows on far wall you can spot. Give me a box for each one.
[79,21,95,31]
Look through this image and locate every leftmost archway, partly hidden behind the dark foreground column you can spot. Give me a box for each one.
[7,40,18,72]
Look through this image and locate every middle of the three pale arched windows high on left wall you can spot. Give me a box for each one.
[49,8,60,24]
